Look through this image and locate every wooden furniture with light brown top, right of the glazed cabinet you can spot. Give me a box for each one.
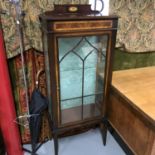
[108,66,155,155]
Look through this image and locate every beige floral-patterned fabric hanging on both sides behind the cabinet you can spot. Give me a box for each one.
[0,0,155,58]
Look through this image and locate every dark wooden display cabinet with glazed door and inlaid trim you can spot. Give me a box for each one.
[40,5,118,154]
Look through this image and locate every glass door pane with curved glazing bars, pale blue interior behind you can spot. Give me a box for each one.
[58,35,108,124]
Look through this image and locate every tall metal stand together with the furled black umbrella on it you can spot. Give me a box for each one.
[5,0,49,155]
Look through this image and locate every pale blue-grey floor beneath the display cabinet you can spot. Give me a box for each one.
[24,129,125,155]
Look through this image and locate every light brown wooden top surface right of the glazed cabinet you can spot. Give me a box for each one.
[112,66,155,121]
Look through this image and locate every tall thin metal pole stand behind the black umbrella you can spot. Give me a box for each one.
[0,0,50,155]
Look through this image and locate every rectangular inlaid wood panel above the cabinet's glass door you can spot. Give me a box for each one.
[53,20,112,32]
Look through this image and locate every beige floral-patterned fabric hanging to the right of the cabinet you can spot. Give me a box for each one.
[110,0,155,52]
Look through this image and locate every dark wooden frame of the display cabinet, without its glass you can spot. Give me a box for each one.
[40,5,118,155]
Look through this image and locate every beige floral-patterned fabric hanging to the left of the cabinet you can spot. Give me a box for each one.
[0,0,88,58]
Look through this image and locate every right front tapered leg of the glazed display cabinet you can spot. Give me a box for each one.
[100,118,107,145]
